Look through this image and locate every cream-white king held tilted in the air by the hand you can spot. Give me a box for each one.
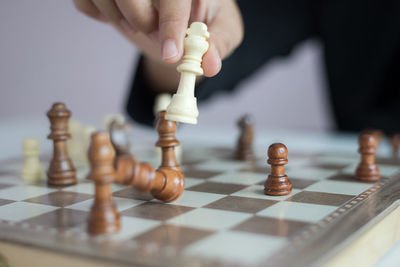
[165,22,210,124]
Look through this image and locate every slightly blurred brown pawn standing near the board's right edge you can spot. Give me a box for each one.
[355,133,381,182]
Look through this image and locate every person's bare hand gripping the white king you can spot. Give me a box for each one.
[74,0,243,77]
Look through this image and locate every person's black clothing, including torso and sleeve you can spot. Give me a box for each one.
[127,0,400,132]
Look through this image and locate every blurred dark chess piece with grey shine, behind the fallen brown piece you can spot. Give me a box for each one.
[109,120,131,156]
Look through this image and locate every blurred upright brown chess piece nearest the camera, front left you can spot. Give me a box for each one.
[88,132,120,234]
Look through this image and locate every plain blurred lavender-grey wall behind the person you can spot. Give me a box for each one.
[0,0,334,131]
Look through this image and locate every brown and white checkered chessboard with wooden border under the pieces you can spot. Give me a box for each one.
[0,132,400,266]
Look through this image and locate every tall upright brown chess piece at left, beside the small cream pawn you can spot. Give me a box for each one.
[47,103,76,186]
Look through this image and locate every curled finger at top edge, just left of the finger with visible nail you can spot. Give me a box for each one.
[115,0,158,34]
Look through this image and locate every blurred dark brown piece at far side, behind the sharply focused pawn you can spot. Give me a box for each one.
[235,114,254,161]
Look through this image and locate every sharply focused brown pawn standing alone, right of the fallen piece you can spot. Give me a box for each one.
[264,143,292,196]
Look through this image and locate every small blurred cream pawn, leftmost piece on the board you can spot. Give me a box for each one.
[21,137,44,183]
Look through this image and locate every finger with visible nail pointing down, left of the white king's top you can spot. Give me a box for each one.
[158,0,191,63]
